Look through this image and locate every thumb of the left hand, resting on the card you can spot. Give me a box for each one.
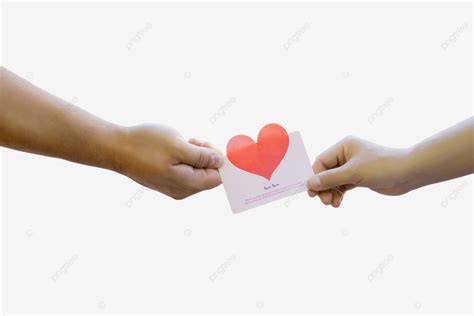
[180,142,223,169]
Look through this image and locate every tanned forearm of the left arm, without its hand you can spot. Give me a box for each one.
[0,67,120,169]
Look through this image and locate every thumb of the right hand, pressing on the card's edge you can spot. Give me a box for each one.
[308,165,352,192]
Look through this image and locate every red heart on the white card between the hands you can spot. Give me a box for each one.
[227,124,290,180]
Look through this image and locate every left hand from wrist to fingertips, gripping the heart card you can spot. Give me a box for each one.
[114,124,223,199]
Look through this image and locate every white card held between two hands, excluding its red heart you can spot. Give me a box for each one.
[219,132,314,213]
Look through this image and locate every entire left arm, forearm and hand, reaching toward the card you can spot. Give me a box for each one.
[0,67,223,199]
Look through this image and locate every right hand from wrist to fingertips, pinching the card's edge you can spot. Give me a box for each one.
[308,137,413,207]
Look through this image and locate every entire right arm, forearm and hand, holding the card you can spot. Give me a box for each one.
[308,116,474,207]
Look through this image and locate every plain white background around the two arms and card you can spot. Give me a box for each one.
[1,3,472,312]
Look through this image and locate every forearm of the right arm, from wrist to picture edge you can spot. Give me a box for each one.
[407,117,474,189]
